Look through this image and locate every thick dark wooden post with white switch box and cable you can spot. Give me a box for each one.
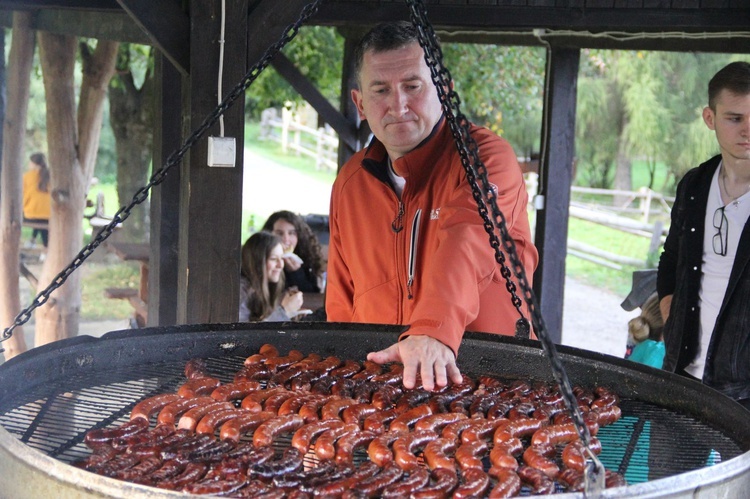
[177,0,248,324]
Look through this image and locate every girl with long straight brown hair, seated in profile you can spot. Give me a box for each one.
[240,231,303,322]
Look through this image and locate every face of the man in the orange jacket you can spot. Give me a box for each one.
[352,42,442,159]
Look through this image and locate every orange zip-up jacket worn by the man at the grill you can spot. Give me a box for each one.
[326,119,538,354]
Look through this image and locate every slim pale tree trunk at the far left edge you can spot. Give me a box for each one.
[0,11,34,360]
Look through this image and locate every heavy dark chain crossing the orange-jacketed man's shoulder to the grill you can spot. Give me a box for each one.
[406,0,604,491]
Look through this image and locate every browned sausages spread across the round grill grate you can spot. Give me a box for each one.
[75,345,625,498]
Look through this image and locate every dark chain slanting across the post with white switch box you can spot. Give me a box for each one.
[0,0,324,353]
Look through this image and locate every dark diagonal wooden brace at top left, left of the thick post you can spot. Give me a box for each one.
[117,0,190,75]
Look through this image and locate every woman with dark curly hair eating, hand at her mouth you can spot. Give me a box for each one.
[263,211,326,293]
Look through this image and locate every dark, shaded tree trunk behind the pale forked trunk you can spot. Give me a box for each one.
[109,67,154,243]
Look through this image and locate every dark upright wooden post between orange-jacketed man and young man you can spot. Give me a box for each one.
[534,48,580,343]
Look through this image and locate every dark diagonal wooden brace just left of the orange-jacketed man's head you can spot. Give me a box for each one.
[271,52,357,152]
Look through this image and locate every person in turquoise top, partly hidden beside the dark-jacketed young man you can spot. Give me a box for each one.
[625,293,664,369]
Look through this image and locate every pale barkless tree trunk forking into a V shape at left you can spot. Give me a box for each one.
[35,32,118,346]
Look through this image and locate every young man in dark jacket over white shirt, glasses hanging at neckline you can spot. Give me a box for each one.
[657,62,750,408]
